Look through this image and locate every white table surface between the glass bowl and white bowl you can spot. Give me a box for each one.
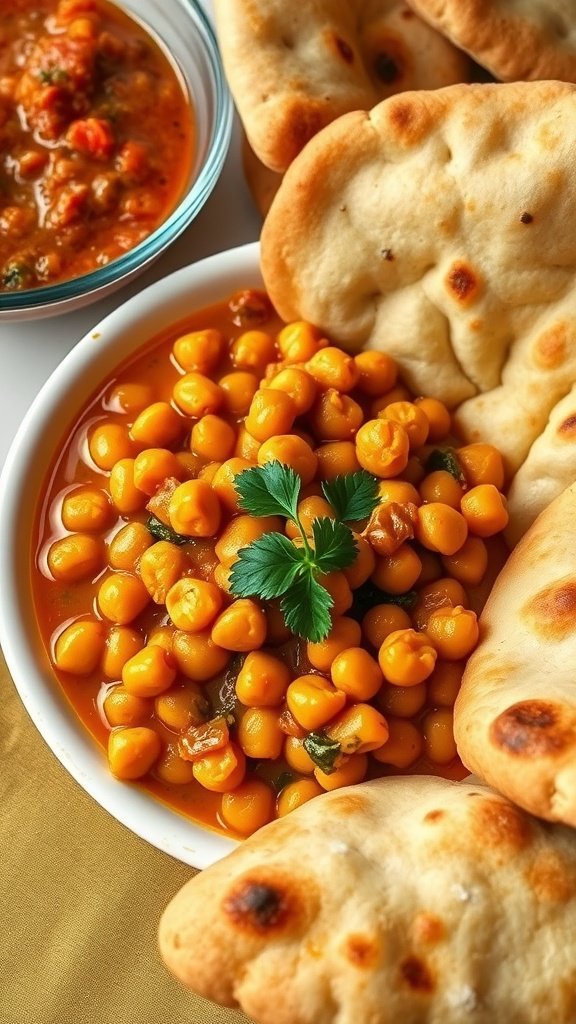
[0,0,261,469]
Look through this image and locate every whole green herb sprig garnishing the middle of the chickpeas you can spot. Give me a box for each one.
[230,461,378,643]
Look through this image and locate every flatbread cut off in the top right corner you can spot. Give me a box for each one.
[408,0,576,82]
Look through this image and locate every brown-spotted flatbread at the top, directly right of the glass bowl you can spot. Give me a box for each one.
[214,0,471,172]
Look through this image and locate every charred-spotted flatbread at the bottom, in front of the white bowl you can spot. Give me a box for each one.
[160,777,576,1024]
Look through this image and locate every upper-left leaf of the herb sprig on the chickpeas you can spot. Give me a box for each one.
[234,459,300,521]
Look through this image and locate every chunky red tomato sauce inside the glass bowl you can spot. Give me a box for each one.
[0,0,194,293]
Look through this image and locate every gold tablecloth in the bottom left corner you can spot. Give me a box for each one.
[0,653,247,1024]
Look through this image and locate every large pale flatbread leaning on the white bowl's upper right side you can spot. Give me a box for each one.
[261,82,576,528]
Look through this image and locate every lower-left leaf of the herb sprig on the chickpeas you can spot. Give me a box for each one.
[230,532,305,601]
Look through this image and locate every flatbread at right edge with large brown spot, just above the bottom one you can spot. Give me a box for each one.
[454,484,576,827]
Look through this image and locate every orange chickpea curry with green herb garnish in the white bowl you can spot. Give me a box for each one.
[34,290,507,836]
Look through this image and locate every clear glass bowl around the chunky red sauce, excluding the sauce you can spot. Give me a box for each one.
[0,0,233,323]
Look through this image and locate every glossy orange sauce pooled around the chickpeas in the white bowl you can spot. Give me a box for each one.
[32,292,487,833]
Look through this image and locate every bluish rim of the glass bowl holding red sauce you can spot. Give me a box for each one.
[0,0,234,312]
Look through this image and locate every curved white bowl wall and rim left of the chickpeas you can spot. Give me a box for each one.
[0,243,262,867]
